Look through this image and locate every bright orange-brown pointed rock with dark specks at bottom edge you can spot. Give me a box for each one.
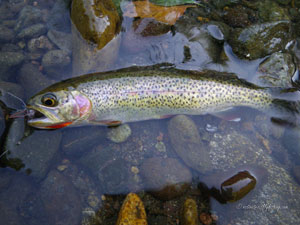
[116,193,147,225]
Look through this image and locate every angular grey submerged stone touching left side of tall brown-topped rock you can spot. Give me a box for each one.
[47,30,72,54]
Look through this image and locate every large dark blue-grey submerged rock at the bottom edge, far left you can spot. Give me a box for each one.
[21,170,81,225]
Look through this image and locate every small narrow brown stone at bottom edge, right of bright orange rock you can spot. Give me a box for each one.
[180,198,199,225]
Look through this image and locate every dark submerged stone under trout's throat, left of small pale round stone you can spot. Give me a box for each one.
[62,126,106,157]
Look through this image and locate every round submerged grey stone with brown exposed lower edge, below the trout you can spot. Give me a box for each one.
[140,157,192,200]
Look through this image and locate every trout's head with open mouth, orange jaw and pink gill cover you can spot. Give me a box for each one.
[27,90,92,129]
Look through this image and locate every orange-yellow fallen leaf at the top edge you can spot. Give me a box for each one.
[123,1,195,25]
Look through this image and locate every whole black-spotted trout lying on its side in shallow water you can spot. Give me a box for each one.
[27,68,298,129]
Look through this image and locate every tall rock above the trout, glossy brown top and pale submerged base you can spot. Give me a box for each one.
[71,0,121,74]
